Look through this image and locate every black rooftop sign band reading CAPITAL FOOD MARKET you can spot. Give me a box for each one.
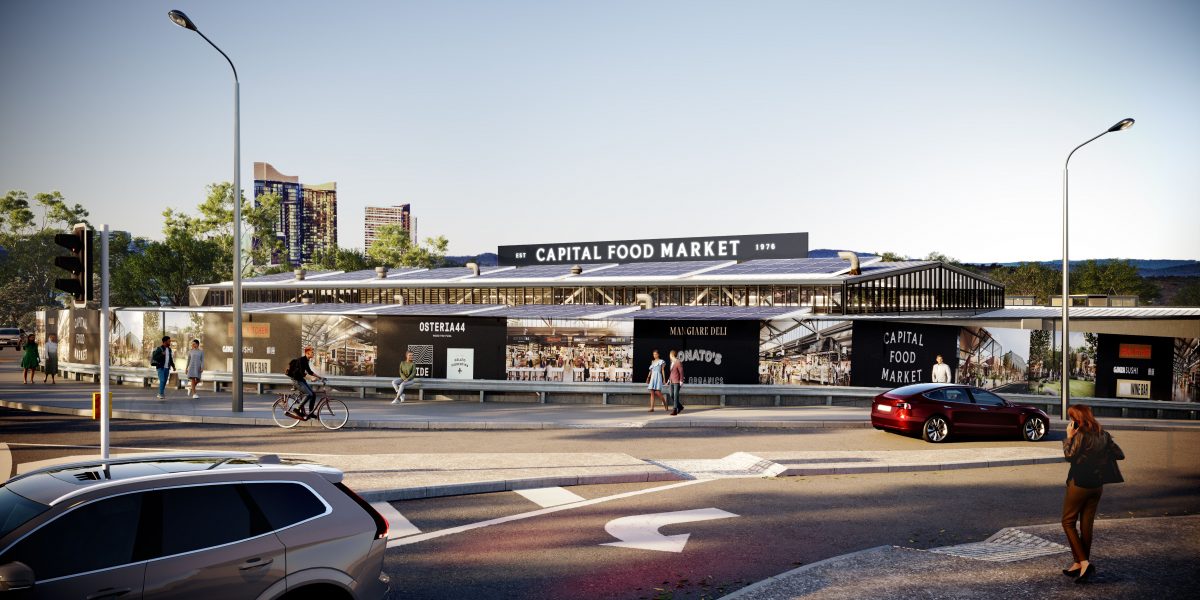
[496,233,809,266]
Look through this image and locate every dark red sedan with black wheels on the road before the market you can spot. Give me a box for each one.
[871,383,1050,444]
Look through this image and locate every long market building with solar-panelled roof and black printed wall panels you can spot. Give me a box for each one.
[37,233,1200,402]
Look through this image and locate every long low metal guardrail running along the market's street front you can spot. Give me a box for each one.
[51,362,1200,419]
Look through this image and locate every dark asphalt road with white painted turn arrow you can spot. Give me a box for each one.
[0,409,1200,599]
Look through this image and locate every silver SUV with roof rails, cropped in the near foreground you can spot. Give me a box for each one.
[0,452,389,600]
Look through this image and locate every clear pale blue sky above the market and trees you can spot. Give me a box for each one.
[0,0,1200,262]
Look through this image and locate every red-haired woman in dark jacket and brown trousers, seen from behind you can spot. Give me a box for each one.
[1062,404,1124,583]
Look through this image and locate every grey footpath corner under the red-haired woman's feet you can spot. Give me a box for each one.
[724,516,1200,600]
